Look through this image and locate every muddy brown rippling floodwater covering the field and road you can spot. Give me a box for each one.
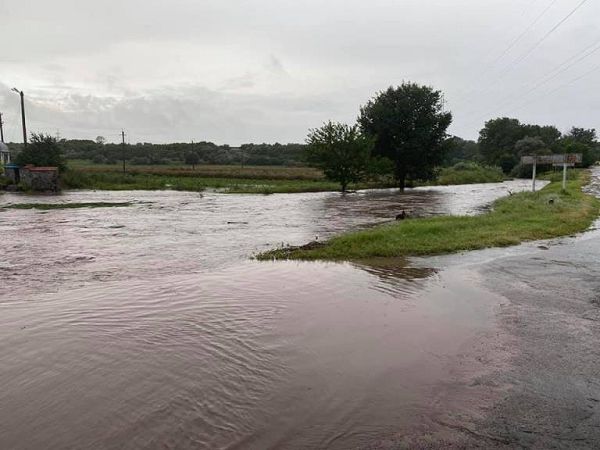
[0,181,540,449]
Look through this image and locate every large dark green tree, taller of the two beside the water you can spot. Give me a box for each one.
[358,83,452,190]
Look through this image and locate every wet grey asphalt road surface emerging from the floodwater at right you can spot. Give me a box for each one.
[379,170,600,449]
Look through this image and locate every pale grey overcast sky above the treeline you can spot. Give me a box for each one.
[0,0,600,145]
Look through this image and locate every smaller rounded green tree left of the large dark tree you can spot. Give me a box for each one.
[306,121,373,192]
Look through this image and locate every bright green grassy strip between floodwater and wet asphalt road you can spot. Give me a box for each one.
[257,175,600,260]
